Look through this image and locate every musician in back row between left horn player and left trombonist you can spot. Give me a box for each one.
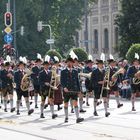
[31,58,42,108]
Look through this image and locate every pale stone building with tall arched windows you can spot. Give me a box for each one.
[77,0,120,58]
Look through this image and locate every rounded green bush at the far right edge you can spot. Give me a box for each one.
[126,44,140,62]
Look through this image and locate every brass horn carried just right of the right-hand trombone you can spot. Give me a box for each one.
[109,68,125,87]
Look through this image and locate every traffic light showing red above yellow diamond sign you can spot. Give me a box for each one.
[4,12,12,26]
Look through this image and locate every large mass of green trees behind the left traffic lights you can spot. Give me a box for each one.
[0,0,93,58]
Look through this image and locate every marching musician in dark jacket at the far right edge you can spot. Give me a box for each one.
[127,58,140,111]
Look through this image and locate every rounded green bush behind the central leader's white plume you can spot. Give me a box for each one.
[73,48,88,62]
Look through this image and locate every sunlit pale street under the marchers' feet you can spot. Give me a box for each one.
[0,96,140,140]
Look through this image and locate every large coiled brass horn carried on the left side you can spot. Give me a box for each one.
[20,69,32,91]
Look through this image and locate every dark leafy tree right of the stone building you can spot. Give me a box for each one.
[116,0,140,57]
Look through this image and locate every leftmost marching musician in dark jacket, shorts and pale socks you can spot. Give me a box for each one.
[1,62,15,112]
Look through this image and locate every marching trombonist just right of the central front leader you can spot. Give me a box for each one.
[90,60,110,117]
